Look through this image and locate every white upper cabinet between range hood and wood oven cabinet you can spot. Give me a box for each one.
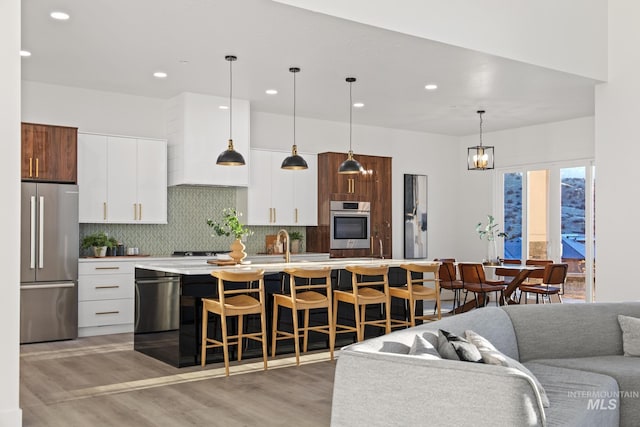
[236,149,318,226]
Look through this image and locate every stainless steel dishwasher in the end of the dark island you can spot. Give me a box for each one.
[135,270,180,333]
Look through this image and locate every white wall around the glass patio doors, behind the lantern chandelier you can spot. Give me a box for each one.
[455,117,602,264]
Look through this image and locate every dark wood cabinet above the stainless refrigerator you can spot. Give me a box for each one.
[21,123,78,183]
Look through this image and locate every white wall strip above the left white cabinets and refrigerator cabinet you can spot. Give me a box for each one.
[22,81,167,138]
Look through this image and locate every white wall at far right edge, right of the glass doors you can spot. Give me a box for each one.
[595,0,640,301]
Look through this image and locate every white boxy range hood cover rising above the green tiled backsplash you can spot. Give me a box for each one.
[167,92,252,187]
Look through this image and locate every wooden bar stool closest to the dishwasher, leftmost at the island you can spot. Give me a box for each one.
[200,270,267,376]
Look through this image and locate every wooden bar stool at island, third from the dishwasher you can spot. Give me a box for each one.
[333,265,391,341]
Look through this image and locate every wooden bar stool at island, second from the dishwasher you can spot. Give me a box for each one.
[271,267,335,365]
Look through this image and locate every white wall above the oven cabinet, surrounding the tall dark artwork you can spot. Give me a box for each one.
[251,112,459,258]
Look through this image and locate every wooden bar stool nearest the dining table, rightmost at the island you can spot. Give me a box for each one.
[389,263,442,327]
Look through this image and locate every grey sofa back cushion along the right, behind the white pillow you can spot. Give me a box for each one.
[504,302,640,362]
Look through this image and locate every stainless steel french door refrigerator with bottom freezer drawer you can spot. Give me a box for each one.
[20,182,79,344]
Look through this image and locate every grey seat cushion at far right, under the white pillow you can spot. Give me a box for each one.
[525,356,640,426]
